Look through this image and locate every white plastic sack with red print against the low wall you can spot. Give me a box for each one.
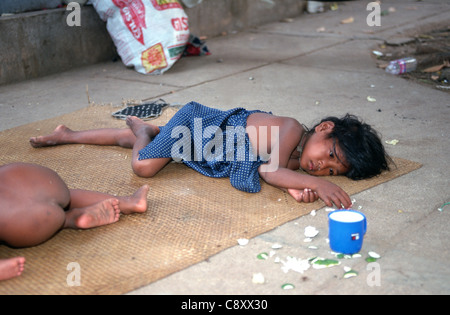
[91,0,190,74]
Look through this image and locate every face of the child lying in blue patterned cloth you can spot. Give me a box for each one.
[300,122,349,176]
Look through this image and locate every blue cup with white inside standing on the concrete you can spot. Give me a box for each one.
[328,210,367,255]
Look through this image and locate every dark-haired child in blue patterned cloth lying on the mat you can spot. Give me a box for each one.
[30,102,390,208]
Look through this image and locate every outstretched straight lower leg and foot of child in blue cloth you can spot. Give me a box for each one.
[30,125,136,149]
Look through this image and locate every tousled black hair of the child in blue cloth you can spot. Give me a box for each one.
[312,114,392,179]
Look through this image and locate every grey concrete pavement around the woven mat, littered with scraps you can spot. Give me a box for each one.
[0,0,450,295]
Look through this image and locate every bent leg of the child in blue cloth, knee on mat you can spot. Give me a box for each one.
[127,117,172,177]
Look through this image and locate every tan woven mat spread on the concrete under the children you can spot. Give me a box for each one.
[0,105,421,294]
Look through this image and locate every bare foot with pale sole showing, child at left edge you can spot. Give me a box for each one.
[64,199,120,229]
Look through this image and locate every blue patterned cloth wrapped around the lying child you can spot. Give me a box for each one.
[139,102,267,193]
